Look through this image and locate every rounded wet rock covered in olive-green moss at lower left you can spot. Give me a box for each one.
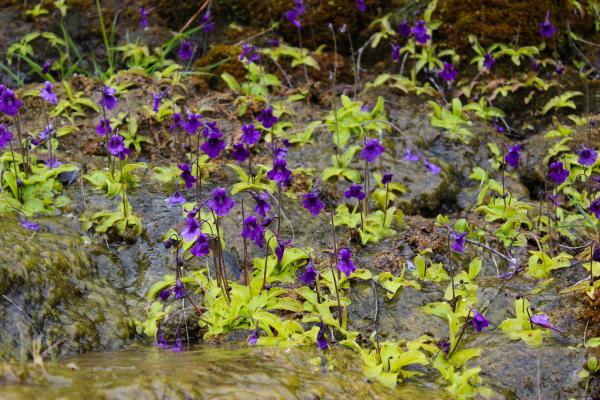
[0,217,132,359]
